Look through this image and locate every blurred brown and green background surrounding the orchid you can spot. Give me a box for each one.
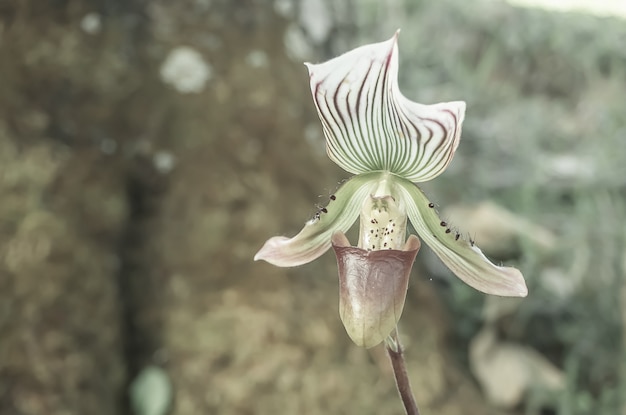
[0,0,626,415]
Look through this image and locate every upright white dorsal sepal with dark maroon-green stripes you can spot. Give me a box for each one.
[306,33,465,182]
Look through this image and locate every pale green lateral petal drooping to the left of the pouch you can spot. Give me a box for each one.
[254,173,380,267]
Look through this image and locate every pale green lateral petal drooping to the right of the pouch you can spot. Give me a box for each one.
[397,179,528,297]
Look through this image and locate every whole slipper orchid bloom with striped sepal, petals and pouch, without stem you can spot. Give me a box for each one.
[255,33,528,347]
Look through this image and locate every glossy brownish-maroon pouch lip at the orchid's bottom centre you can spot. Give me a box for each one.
[332,232,421,348]
